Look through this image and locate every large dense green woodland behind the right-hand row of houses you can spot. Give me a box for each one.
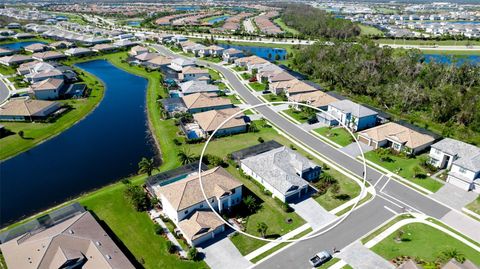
[292,40,480,144]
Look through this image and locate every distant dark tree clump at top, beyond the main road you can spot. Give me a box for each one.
[281,4,360,39]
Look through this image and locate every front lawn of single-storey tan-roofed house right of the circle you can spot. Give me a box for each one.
[365,151,443,192]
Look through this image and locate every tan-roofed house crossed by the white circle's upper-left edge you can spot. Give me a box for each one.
[193,107,247,137]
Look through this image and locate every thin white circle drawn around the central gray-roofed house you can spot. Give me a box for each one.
[198,101,367,243]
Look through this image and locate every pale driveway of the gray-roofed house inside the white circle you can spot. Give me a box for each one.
[290,198,336,230]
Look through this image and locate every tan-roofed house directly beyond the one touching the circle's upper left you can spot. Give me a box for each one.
[182,93,233,114]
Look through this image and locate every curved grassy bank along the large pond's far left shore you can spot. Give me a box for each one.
[0,66,105,160]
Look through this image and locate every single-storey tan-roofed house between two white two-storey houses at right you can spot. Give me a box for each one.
[358,122,435,155]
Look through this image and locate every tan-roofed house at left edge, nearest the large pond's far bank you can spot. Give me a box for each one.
[0,98,61,121]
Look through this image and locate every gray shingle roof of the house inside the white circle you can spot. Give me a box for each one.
[242,147,317,194]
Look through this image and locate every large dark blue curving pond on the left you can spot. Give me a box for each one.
[0,60,156,226]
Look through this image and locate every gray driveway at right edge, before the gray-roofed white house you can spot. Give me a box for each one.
[430,183,478,210]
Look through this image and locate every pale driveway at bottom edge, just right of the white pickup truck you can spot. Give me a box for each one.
[337,242,395,269]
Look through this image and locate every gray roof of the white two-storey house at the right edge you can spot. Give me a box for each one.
[432,138,480,171]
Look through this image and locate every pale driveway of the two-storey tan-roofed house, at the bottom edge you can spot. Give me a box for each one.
[200,233,251,269]
